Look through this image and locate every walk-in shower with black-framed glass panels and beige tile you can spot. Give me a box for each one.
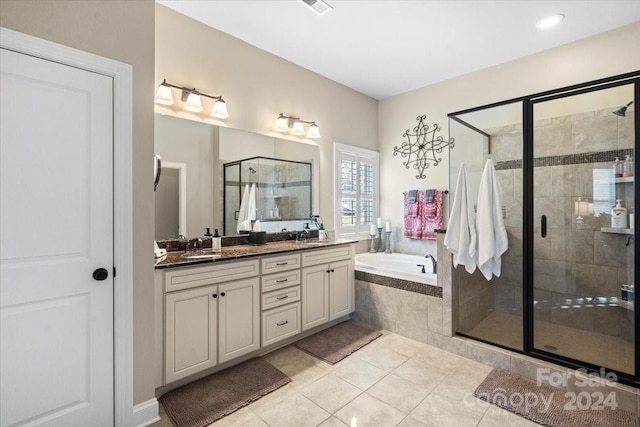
[449,74,640,385]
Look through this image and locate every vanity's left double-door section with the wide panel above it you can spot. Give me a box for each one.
[164,260,260,384]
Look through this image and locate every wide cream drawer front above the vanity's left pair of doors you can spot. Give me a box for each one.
[164,259,260,292]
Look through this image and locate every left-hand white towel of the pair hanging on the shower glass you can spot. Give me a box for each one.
[444,162,477,274]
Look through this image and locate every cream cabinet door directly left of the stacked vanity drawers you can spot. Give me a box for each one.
[218,277,260,363]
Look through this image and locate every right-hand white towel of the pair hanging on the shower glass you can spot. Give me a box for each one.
[476,159,509,280]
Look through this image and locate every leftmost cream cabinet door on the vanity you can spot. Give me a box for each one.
[165,286,218,383]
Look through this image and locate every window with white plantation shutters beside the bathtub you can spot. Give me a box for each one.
[334,143,379,239]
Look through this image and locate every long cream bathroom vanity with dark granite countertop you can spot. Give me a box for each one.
[155,240,355,386]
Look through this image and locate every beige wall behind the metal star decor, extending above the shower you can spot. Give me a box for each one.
[378,22,640,254]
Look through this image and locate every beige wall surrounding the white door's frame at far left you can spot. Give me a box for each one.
[0,0,155,403]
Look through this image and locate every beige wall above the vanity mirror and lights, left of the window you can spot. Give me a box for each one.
[156,5,378,234]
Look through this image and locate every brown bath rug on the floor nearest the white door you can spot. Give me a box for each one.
[160,358,291,427]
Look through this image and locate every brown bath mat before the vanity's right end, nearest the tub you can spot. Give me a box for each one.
[295,320,382,365]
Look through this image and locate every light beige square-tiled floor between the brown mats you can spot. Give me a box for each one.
[153,331,537,427]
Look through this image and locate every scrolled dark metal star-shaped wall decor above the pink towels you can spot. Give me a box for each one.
[393,115,454,179]
